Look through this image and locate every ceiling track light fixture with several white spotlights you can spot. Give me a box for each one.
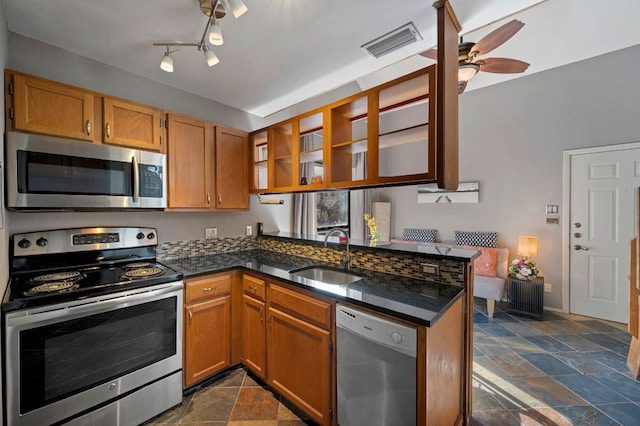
[153,0,247,72]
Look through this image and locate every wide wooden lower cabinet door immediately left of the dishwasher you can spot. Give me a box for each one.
[267,308,331,424]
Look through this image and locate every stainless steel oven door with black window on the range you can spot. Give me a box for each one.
[5,281,182,425]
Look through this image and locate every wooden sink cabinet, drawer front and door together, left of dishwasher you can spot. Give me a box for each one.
[267,283,334,425]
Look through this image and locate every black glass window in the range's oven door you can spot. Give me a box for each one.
[20,297,177,413]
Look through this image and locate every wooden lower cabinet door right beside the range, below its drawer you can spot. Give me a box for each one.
[183,296,231,388]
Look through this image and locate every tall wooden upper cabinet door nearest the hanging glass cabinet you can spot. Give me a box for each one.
[215,126,249,209]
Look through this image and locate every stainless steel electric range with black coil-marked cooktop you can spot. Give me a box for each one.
[2,227,183,425]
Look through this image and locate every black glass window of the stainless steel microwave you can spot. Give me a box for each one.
[18,151,133,196]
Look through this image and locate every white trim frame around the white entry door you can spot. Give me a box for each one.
[562,142,640,313]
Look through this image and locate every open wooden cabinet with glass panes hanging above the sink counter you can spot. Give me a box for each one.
[251,65,438,193]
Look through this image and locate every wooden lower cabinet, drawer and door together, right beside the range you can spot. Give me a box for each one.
[183,274,231,388]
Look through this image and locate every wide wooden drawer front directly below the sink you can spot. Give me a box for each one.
[268,283,331,329]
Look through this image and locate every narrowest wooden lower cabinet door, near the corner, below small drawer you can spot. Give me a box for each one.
[242,294,266,379]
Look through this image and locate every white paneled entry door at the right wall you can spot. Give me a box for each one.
[569,148,640,323]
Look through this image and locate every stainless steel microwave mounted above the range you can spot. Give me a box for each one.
[5,132,167,210]
